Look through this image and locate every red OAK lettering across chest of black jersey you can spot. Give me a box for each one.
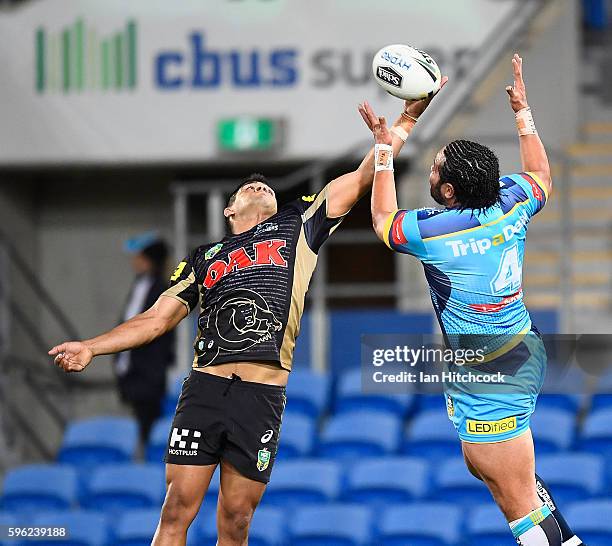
[204,239,287,288]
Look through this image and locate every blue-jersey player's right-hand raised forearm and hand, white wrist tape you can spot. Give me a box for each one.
[506,53,552,194]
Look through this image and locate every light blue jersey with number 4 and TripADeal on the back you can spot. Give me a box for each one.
[384,172,548,358]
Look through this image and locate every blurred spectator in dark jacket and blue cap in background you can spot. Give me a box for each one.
[115,233,174,445]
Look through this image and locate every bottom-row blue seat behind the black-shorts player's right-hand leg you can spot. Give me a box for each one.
[198,506,287,546]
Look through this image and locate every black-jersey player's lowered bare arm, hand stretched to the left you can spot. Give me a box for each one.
[49,296,187,372]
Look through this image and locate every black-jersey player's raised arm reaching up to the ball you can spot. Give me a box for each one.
[327,77,448,218]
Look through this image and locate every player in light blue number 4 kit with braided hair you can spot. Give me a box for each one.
[360,55,583,546]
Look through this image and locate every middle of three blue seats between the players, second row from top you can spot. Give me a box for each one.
[319,411,401,458]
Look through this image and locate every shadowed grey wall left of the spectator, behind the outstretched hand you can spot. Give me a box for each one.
[38,174,173,394]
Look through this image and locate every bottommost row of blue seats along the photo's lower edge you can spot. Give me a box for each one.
[0,500,612,546]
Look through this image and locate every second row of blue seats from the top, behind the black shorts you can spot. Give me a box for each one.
[58,406,612,468]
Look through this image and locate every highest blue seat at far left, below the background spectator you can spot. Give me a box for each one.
[58,417,138,467]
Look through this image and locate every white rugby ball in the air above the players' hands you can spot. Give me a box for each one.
[372,44,442,100]
